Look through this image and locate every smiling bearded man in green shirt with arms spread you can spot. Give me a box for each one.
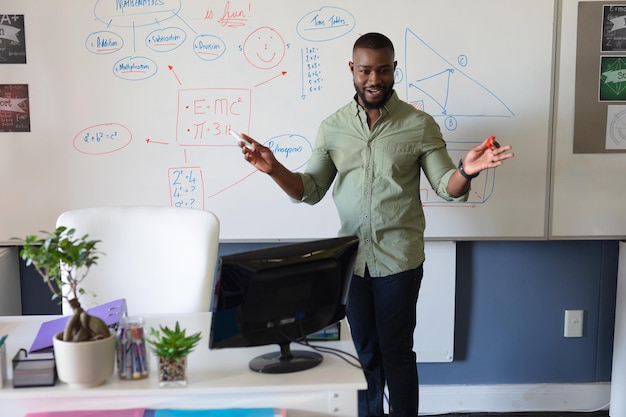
[240,33,513,417]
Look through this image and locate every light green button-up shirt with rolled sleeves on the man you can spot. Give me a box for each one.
[299,91,467,277]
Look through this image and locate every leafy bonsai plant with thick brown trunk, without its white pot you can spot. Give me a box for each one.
[20,226,110,342]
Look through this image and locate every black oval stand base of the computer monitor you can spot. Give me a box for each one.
[249,343,323,374]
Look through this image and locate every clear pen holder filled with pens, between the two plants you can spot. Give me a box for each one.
[117,317,149,379]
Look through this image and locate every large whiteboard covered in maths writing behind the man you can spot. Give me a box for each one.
[0,0,555,241]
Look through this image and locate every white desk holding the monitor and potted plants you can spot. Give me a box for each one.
[0,313,366,417]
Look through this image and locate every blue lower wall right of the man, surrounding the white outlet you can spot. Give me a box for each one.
[419,241,618,384]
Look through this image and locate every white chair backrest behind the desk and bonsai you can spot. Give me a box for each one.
[57,206,219,315]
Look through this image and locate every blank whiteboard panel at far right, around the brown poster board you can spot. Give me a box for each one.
[549,1,626,238]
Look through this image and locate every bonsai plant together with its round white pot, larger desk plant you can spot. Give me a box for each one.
[20,226,115,387]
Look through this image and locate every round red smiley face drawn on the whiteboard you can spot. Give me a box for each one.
[243,26,286,69]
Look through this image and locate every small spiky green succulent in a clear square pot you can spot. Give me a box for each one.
[146,321,201,387]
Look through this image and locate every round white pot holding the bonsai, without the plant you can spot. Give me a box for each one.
[52,333,115,388]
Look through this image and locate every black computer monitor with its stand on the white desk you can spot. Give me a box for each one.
[209,236,359,373]
